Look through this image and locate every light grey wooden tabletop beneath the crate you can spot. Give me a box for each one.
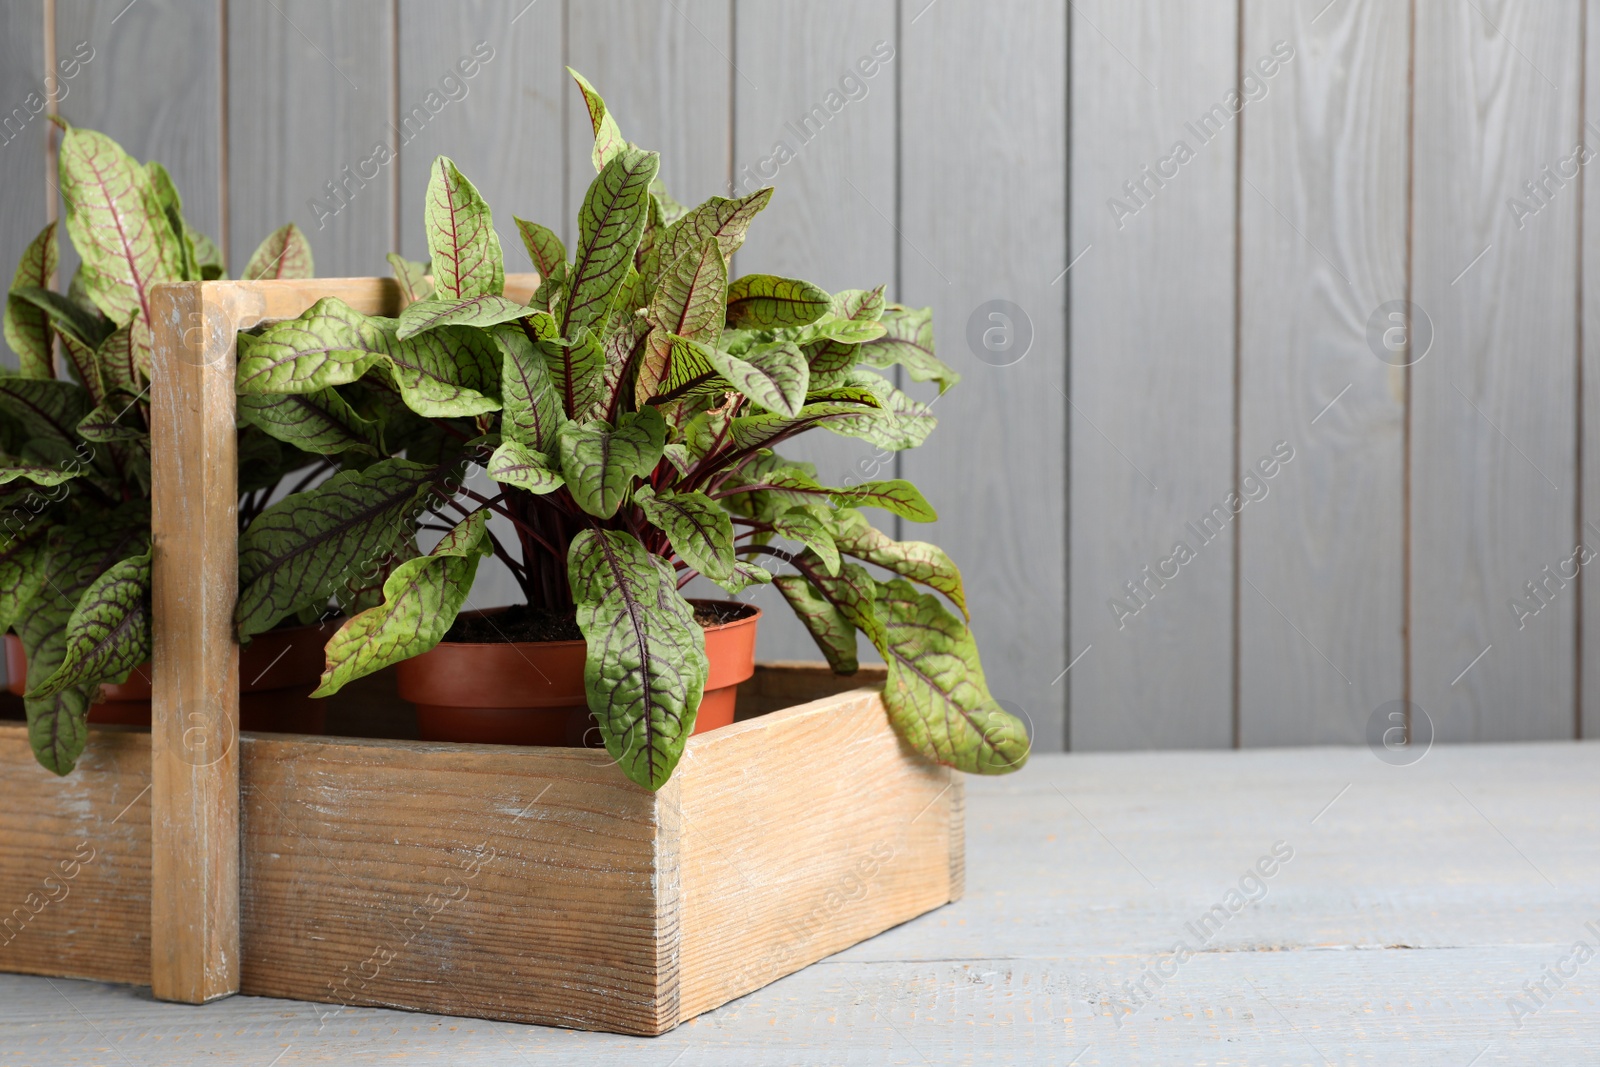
[0,742,1600,1067]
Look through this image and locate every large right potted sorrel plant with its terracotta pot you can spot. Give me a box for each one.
[237,74,1027,789]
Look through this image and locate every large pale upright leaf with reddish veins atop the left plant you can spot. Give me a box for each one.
[59,126,184,334]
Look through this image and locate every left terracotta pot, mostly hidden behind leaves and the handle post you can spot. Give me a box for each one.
[5,621,338,734]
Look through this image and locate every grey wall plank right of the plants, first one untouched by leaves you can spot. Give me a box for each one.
[1075,0,1248,749]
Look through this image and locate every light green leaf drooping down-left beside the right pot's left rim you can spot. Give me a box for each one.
[312,510,491,696]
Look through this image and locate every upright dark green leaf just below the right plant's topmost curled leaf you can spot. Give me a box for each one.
[562,147,661,338]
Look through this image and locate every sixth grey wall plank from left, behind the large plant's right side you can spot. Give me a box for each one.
[729,0,896,661]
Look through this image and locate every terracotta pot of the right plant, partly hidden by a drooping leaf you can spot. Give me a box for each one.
[397,600,762,747]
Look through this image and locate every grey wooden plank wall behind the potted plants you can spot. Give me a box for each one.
[0,0,1600,749]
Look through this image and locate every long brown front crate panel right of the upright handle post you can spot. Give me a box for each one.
[242,736,677,1033]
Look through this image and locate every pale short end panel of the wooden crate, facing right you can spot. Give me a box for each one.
[664,691,960,1019]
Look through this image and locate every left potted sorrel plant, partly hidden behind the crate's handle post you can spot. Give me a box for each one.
[0,123,356,774]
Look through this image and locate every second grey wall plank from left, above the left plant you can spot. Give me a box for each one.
[56,0,222,275]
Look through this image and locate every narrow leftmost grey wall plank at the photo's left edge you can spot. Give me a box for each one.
[0,0,47,368]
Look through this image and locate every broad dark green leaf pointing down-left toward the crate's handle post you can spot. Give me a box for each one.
[234,459,442,640]
